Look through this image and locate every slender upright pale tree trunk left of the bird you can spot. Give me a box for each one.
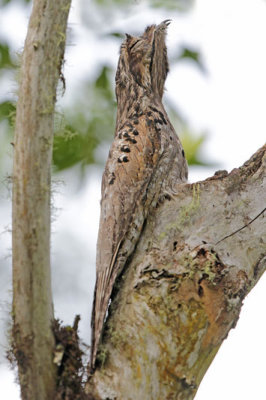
[12,0,71,400]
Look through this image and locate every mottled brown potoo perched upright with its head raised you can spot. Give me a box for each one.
[90,20,188,371]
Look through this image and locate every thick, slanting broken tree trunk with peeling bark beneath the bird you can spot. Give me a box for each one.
[86,146,266,400]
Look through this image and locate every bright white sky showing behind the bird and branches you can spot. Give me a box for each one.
[0,0,266,400]
